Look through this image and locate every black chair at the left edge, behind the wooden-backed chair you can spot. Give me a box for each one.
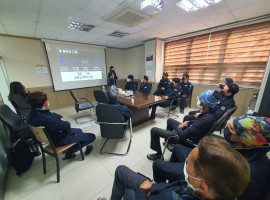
[0,104,39,154]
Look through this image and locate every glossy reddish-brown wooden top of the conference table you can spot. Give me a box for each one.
[117,92,165,109]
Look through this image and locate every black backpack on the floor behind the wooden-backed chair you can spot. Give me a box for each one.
[7,139,34,176]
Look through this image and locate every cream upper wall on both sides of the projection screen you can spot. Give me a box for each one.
[0,36,145,88]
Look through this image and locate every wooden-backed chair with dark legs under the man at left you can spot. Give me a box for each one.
[30,126,84,183]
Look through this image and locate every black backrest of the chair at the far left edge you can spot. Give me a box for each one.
[0,104,24,132]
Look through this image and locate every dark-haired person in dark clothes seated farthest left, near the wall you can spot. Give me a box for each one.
[8,81,31,115]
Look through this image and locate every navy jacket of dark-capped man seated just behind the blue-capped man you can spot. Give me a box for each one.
[216,90,235,118]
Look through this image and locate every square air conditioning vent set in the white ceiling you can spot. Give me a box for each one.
[104,2,156,27]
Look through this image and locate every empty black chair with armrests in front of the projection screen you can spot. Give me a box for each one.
[69,90,95,124]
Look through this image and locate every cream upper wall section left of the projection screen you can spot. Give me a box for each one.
[0,36,52,88]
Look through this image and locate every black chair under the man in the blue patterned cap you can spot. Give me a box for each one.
[162,106,237,157]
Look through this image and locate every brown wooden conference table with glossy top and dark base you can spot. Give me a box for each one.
[117,92,166,127]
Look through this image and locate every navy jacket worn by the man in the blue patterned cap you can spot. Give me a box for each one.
[176,111,218,144]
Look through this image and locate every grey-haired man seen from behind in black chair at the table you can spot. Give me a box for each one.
[107,90,133,120]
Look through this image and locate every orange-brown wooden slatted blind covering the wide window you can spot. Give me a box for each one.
[164,22,270,86]
